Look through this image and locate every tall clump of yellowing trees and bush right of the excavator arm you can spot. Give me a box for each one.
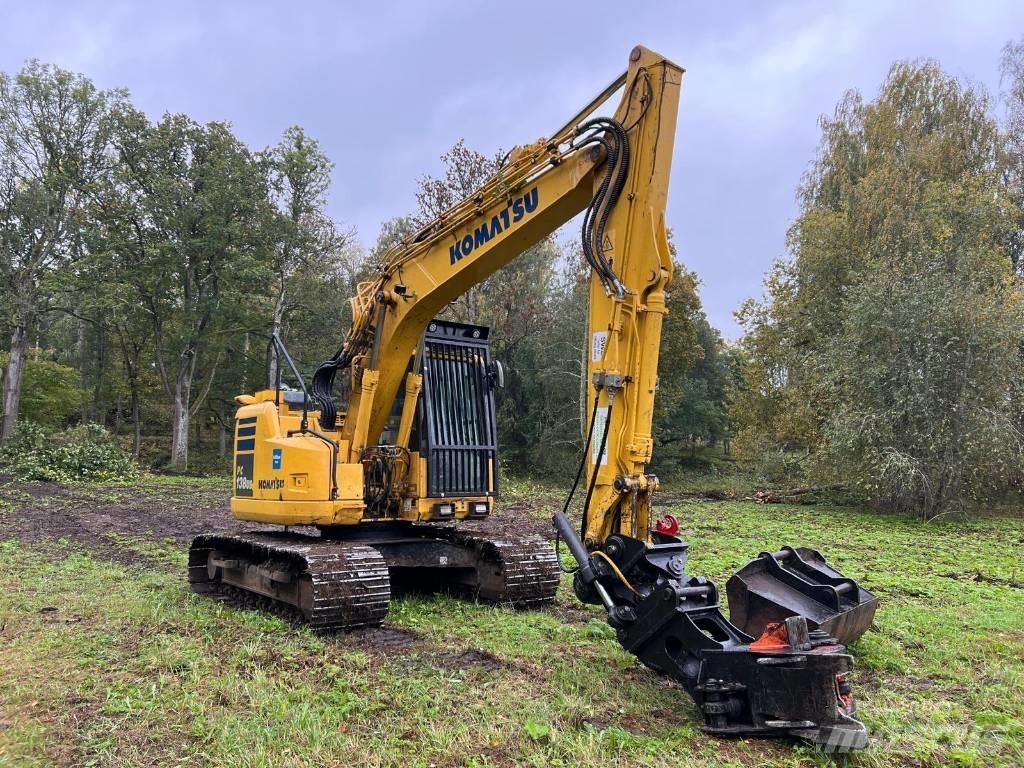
[736,61,1024,515]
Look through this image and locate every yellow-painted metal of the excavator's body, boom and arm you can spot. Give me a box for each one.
[231,47,683,546]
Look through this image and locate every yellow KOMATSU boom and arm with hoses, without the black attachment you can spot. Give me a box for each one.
[313,47,683,547]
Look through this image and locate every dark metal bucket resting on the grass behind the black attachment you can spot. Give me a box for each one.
[725,547,879,645]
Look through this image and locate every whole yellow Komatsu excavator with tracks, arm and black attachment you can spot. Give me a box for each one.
[188,46,878,750]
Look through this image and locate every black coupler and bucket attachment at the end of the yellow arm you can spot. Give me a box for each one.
[553,513,877,752]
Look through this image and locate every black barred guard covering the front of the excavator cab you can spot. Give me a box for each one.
[420,321,498,498]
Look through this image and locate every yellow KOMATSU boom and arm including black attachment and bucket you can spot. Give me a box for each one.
[301,47,874,749]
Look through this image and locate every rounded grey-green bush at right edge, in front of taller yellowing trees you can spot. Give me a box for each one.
[825,262,1024,516]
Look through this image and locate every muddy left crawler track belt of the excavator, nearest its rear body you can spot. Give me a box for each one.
[188,534,391,631]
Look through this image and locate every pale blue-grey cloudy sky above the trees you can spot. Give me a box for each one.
[0,0,1024,338]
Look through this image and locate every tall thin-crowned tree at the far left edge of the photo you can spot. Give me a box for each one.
[0,61,126,441]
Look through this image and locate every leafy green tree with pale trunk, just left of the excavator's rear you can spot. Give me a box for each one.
[118,110,272,470]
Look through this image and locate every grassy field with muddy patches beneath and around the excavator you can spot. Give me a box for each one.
[0,477,1024,768]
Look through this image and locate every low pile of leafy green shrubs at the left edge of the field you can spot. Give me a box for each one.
[0,421,138,482]
